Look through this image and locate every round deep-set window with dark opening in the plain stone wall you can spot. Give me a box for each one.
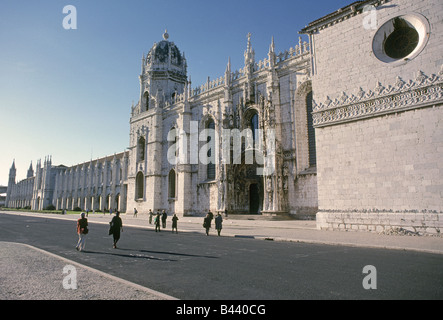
[372,14,429,63]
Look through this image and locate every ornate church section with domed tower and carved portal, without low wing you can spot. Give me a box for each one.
[127,33,317,215]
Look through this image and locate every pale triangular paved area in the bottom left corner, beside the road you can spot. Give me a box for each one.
[0,241,175,300]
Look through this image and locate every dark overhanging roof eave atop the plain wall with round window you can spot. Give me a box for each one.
[299,0,390,34]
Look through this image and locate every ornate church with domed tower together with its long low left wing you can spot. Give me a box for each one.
[7,32,317,218]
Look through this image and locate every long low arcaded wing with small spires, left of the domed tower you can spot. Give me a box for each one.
[5,153,127,211]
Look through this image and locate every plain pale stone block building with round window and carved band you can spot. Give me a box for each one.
[302,0,443,233]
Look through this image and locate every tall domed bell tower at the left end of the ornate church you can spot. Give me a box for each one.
[127,30,188,212]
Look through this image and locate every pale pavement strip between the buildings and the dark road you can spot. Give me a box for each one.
[5,212,443,254]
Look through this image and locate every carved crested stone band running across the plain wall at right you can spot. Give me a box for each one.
[312,66,443,128]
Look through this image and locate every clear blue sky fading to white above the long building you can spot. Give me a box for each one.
[0,0,353,185]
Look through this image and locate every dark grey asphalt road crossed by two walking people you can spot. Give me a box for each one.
[0,215,443,300]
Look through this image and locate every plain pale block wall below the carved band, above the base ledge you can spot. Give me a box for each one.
[317,107,443,212]
